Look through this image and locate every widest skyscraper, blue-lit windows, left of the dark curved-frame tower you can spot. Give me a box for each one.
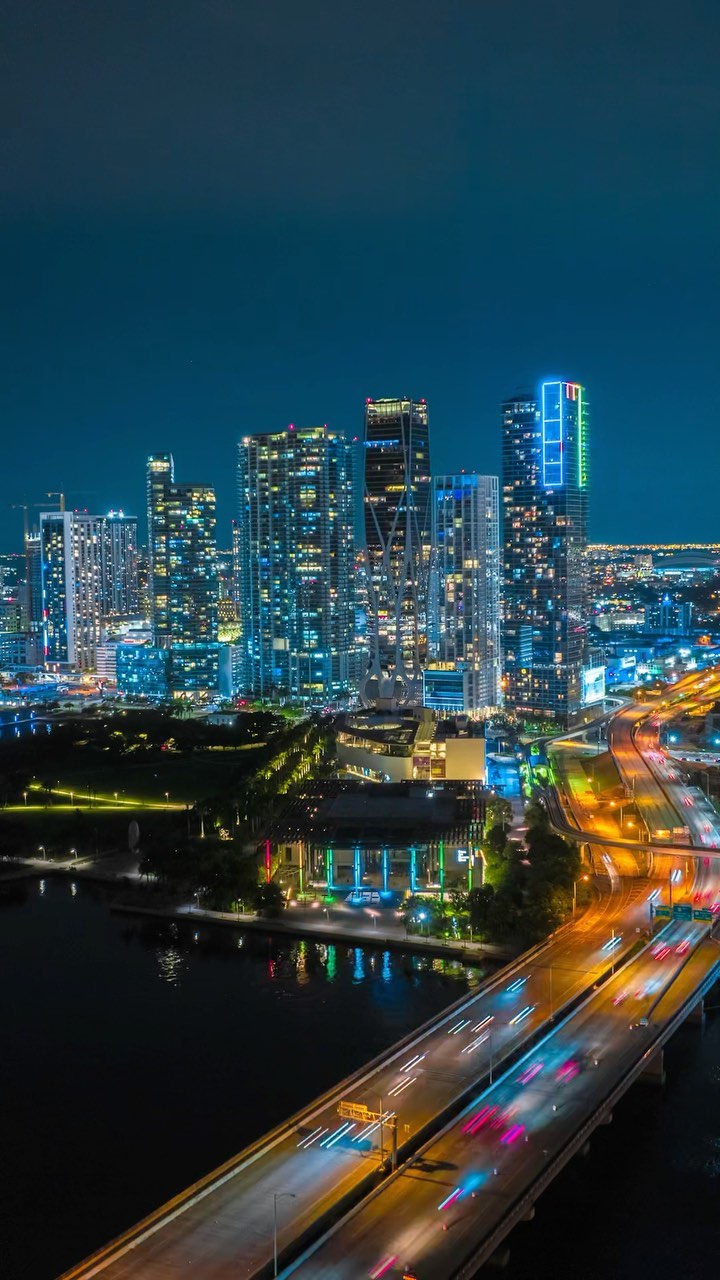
[236,426,357,707]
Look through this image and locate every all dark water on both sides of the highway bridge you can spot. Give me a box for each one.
[0,879,720,1280]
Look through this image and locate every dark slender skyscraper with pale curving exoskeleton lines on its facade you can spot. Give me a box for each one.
[360,399,430,704]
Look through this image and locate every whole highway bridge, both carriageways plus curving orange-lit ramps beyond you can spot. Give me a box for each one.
[63,677,720,1280]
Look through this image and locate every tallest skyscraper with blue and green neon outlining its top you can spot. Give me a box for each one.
[502,380,588,726]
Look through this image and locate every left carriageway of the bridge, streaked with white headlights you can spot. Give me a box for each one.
[58,879,660,1280]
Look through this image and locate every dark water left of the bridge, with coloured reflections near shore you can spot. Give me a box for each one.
[0,878,480,1280]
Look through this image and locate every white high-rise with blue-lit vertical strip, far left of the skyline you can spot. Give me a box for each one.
[40,511,105,671]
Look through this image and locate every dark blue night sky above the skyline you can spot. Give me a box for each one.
[0,0,720,549]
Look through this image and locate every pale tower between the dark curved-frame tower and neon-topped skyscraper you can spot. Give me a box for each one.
[428,472,501,712]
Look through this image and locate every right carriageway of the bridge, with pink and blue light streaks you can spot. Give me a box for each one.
[283,924,720,1280]
